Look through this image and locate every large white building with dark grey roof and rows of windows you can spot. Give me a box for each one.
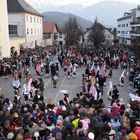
[7,0,43,53]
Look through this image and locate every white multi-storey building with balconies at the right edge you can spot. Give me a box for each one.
[117,6,140,44]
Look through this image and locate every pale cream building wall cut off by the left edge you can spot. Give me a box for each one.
[0,0,10,58]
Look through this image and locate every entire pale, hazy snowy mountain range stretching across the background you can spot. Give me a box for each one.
[41,1,137,27]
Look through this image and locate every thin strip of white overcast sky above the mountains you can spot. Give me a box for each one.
[26,0,140,7]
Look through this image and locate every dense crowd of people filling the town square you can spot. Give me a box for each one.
[0,45,140,140]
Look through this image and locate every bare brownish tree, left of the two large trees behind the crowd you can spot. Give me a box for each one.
[65,17,82,49]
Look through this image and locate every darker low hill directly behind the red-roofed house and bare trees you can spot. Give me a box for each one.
[43,12,93,30]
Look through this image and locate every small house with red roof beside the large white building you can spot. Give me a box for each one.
[43,22,59,46]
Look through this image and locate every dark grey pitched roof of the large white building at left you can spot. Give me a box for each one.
[7,0,42,16]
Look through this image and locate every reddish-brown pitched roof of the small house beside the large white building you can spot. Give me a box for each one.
[43,22,58,33]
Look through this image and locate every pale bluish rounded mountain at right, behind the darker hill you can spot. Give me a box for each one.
[78,1,137,26]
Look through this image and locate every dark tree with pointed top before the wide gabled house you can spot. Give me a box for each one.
[88,19,105,47]
